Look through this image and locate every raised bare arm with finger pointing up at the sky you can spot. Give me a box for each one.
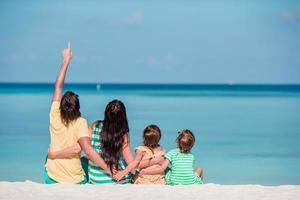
[52,42,72,101]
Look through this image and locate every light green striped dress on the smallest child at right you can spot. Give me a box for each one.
[165,149,203,185]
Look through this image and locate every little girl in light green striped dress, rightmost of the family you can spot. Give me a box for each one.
[140,130,203,185]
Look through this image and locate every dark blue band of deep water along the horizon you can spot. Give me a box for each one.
[0,82,300,92]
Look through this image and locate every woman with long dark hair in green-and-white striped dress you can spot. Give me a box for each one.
[48,100,164,184]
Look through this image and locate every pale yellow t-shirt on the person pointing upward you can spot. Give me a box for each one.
[46,101,89,183]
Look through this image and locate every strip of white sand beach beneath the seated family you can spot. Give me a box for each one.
[0,181,300,200]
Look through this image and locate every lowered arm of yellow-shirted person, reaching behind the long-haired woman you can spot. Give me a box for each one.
[78,137,111,174]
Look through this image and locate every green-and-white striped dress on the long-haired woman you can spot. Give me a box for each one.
[88,122,132,184]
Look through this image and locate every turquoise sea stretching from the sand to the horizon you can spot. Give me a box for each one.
[0,84,300,185]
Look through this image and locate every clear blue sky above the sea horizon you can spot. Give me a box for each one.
[0,0,300,84]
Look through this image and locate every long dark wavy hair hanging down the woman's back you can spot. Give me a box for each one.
[101,100,129,171]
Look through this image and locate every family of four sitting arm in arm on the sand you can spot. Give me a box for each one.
[44,43,203,185]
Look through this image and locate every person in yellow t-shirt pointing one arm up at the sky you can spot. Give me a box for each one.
[44,43,110,184]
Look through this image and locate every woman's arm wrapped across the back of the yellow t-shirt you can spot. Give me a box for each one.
[48,143,81,159]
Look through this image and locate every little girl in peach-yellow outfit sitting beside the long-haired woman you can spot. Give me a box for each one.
[114,124,166,184]
